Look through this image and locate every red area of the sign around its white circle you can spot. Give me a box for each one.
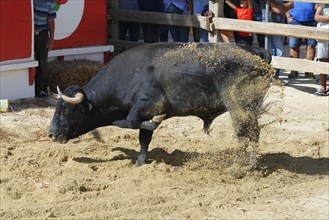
[54,0,107,49]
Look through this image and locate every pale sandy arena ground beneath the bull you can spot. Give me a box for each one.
[0,72,329,219]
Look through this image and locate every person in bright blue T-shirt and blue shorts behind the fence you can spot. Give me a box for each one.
[286,2,317,79]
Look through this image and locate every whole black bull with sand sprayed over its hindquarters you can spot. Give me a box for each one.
[49,43,274,165]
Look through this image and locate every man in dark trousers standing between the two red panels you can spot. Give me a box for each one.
[33,0,56,97]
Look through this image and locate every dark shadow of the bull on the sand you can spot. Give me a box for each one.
[73,147,329,176]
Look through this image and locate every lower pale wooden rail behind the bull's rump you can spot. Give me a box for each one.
[271,56,329,75]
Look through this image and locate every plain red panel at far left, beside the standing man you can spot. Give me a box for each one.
[0,0,32,61]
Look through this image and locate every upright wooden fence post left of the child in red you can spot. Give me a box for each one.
[208,0,224,43]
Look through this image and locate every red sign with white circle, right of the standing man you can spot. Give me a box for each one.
[54,0,107,49]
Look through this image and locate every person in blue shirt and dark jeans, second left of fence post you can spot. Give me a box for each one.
[165,0,193,42]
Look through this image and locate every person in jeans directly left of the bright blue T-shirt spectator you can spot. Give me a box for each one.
[268,0,292,78]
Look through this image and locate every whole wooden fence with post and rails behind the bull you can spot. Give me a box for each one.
[108,0,329,74]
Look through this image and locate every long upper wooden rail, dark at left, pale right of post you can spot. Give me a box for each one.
[109,9,329,41]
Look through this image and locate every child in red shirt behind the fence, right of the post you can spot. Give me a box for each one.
[225,0,254,45]
